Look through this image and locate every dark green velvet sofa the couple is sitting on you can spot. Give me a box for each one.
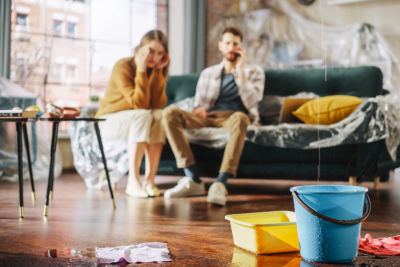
[159,67,400,185]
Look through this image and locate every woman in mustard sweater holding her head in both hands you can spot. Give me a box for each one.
[96,30,169,197]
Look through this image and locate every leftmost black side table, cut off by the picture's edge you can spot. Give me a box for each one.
[0,117,36,218]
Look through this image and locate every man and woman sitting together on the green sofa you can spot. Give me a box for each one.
[97,27,265,205]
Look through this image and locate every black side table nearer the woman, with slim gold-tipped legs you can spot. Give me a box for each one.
[40,117,116,217]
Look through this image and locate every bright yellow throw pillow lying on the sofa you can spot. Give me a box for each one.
[293,95,362,124]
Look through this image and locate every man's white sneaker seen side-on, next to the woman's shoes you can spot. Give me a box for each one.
[164,176,206,198]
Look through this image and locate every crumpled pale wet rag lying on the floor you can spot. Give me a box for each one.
[96,242,171,263]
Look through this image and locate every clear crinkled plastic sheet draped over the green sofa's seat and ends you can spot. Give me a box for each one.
[69,93,400,188]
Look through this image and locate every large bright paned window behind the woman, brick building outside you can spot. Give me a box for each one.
[10,0,168,118]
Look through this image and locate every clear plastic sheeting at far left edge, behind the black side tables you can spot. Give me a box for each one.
[0,77,61,181]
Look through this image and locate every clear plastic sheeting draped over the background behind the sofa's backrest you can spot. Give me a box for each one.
[214,1,400,94]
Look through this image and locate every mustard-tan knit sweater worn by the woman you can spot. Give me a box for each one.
[96,57,167,117]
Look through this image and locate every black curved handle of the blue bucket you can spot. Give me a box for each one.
[292,191,371,225]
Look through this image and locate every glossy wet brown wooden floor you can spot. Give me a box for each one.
[0,173,400,266]
